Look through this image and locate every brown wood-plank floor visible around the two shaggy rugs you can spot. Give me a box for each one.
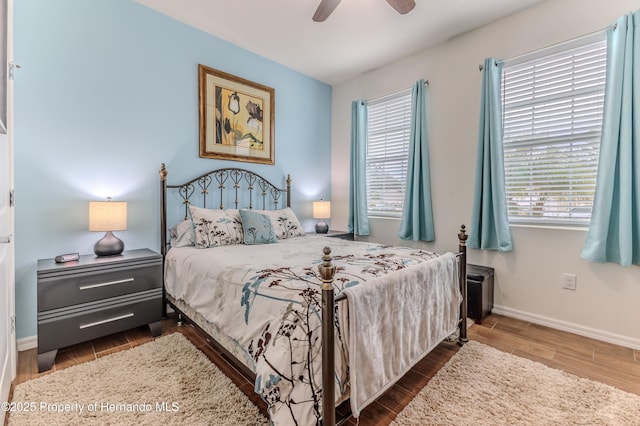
[14,315,640,426]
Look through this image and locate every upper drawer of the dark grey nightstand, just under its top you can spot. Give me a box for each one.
[38,263,162,312]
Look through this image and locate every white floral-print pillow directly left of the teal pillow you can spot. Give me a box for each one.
[189,206,244,248]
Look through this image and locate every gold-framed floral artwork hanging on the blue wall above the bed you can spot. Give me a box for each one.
[198,65,275,164]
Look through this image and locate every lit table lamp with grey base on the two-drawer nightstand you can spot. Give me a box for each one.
[89,197,127,256]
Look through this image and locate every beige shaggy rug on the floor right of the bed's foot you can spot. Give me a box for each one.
[393,341,640,426]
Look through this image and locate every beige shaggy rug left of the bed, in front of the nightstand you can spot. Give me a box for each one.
[9,333,269,426]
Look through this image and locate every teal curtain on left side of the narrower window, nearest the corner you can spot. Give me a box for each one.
[347,100,369,235]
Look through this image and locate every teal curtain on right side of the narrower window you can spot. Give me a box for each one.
[398,80,436,241]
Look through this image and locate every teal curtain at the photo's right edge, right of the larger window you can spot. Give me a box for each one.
[582,11,640,266]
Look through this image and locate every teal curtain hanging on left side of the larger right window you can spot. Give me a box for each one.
[467,58,512,251]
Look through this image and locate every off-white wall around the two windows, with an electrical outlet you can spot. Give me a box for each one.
[331,0,640,349]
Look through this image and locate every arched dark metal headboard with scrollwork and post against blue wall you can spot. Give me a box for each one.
[160,163,291,256]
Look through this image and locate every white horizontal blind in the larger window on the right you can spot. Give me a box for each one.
[502,37,606,225]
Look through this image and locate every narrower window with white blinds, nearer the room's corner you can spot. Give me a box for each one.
[367,90,411,217]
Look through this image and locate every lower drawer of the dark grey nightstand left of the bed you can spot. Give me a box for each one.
[38,288,162,353]
